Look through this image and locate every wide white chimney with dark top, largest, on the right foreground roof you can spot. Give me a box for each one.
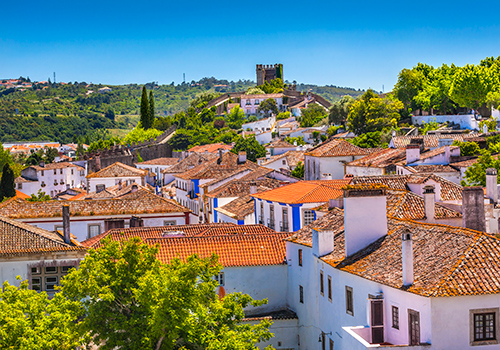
[344,186,387,257]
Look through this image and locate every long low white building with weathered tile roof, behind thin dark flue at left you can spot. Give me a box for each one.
[0,189,190,241]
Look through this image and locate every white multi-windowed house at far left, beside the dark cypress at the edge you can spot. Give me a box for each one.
[14,162,86,197]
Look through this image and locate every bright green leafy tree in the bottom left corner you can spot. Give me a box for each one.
[0,281,84,350]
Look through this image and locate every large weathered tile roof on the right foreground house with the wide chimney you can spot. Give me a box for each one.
[289,209,500,297]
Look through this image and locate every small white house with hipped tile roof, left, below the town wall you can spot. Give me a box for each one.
[87,162,149,192]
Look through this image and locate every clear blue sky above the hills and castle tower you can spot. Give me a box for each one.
[0,0,500,91]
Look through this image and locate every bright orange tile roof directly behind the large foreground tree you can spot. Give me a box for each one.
[150,233,289,267]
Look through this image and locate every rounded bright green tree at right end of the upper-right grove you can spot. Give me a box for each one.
[450,64,494,110]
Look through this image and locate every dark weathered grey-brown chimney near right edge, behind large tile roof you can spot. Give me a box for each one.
[462,187,486,232]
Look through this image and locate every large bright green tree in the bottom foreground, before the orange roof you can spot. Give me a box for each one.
[61,237,271,350]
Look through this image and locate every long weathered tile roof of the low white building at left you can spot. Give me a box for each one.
[0,189,190,219]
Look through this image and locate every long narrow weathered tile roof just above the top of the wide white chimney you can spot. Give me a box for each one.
[352,174,462,201]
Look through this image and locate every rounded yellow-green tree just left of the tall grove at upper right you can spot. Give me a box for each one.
[347,89,403,135]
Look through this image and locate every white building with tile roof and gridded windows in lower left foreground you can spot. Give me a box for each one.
[0,217,87,295]
